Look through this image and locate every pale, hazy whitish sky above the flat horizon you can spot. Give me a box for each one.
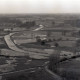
[0,0,80,14]
